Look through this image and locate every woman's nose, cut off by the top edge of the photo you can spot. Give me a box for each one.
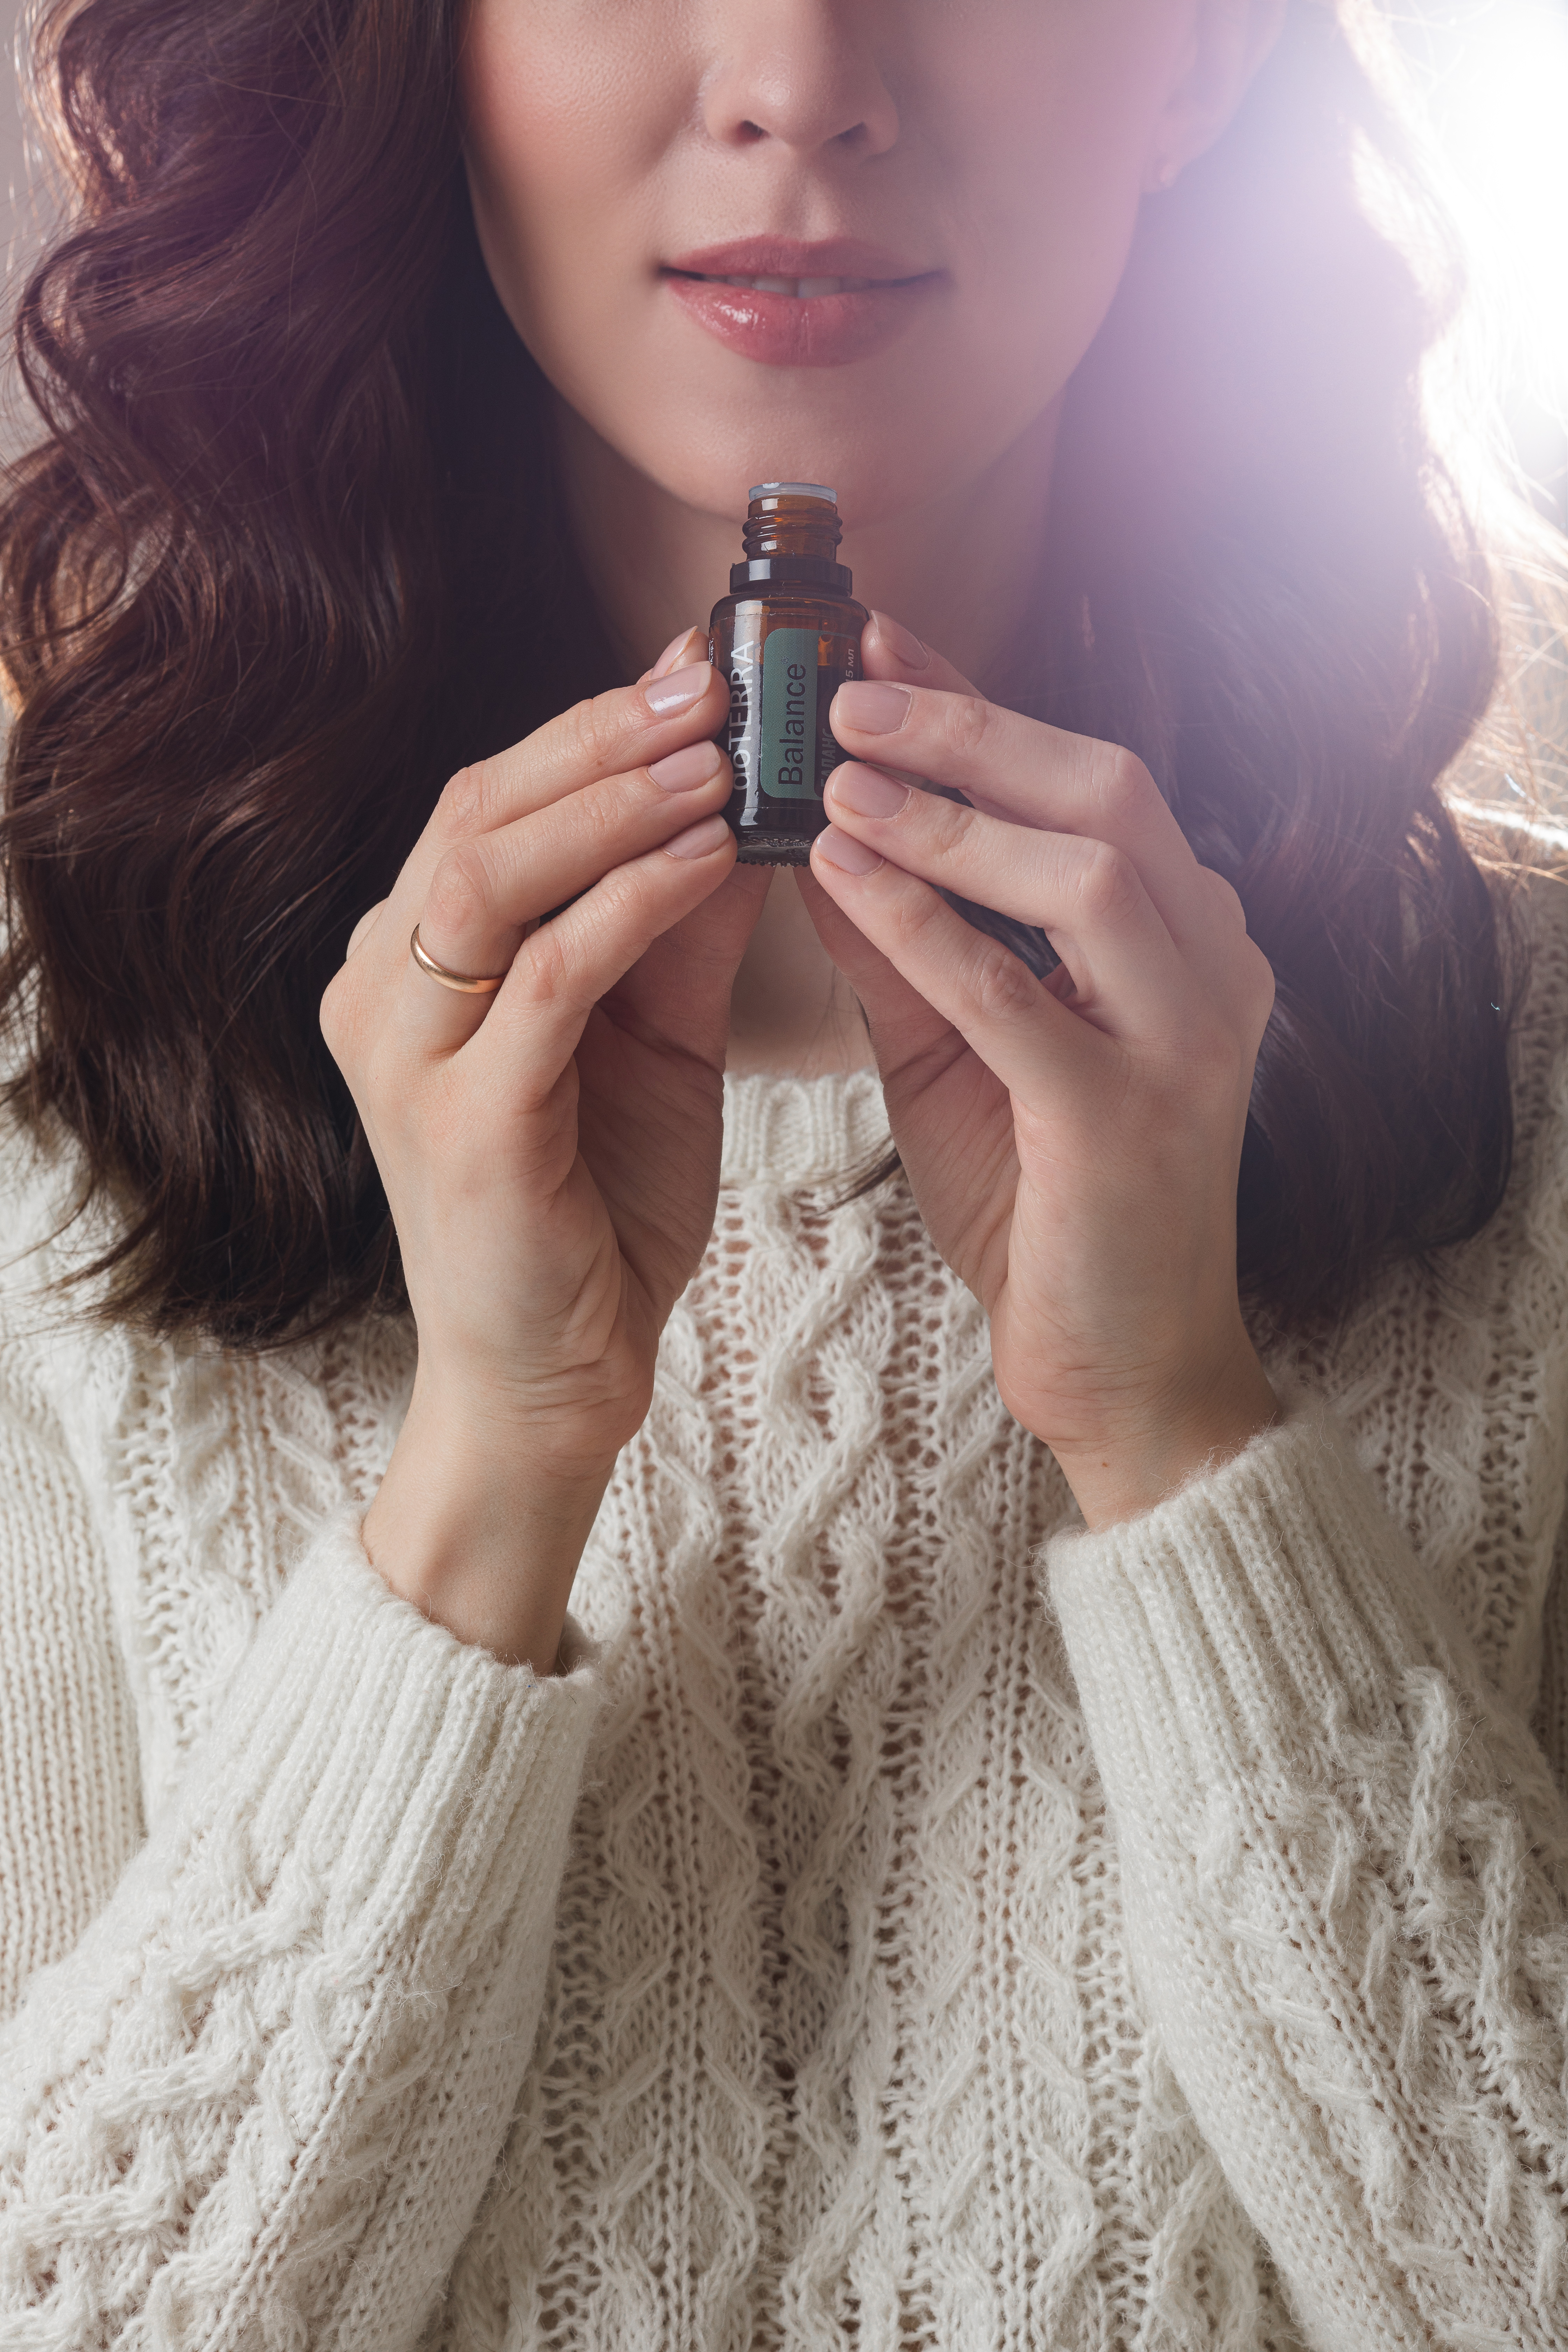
[701,0,898,155]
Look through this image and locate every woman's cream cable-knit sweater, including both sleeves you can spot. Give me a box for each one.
[0,837,1568,2352]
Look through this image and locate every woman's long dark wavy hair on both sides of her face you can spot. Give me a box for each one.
[0,0,1542,1345]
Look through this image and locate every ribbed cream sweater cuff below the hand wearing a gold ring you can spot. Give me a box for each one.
[169,1512,602,1983]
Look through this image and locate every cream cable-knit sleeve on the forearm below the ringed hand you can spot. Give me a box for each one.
[0,1517,597,2352]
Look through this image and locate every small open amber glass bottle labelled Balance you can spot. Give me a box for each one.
[708,482,865,866]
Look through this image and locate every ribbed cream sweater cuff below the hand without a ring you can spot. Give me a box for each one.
[1044,1392,1479,1797]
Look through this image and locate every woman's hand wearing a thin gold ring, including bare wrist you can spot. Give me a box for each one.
[322,633,769,1670]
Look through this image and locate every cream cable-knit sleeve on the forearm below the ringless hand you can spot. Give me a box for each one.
[1051,1409,1568,2352]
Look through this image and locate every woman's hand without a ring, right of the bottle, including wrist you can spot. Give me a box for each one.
[802,618,1276,1526]
